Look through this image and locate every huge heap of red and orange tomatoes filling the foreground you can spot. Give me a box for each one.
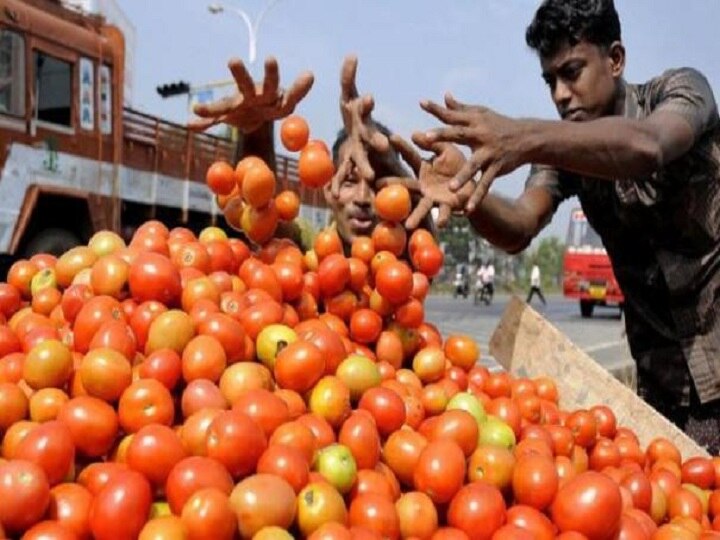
[0,122,720,540]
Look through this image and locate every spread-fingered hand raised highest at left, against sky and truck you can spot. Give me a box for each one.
[188,57,314,133]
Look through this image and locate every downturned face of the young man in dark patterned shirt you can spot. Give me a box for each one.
[540,41,625,122]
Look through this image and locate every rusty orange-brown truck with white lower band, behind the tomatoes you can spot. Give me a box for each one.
[0,0,326,268]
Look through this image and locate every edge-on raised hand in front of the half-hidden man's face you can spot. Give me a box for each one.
[331,56,390,197]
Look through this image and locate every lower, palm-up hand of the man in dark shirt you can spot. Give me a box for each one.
[389,133,473,229]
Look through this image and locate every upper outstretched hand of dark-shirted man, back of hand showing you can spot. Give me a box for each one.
[420,94,525,212]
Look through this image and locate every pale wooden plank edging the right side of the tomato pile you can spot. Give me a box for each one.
[490,297,708,459]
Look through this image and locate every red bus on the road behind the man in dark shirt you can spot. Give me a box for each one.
[563,208,625,317]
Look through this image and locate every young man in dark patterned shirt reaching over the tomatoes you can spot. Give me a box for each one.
[411,0,720,454]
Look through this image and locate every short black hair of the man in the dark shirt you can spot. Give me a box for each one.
[525,0,620,57]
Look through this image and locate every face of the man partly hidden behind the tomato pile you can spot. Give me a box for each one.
[325,141,401,244]
